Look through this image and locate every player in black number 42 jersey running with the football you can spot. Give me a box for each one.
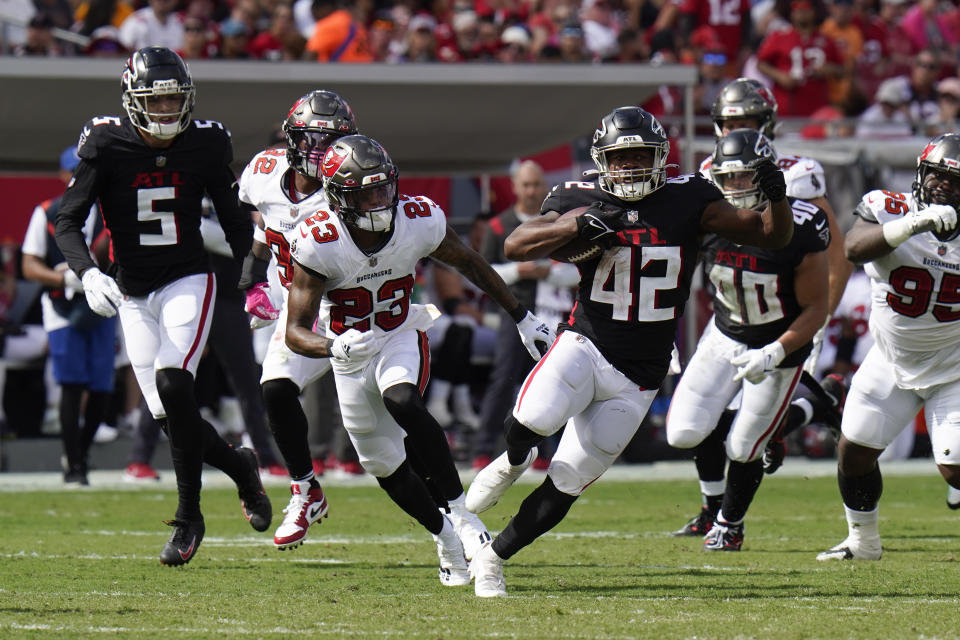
[467,107,793,597]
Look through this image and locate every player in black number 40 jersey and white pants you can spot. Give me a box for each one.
[667,129,830,551]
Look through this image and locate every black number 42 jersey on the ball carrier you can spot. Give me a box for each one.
[541,175,723,389]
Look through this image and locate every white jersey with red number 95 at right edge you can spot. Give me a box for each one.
[855,190,960,389]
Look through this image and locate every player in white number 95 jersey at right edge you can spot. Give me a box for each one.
[817,133,960,560]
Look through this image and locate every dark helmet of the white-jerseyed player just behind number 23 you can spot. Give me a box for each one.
[281,89,357,179]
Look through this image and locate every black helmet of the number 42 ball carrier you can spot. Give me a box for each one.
[590,107,670,201]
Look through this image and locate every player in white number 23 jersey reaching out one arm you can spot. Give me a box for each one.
[286,135,555,586]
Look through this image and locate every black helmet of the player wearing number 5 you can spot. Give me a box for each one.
[120,47,197,140]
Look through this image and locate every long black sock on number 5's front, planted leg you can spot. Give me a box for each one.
[157,368,204,520]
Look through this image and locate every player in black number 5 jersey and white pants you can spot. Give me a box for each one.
[56,47,272,565]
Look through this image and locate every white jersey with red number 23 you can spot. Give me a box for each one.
[290,195,447,338]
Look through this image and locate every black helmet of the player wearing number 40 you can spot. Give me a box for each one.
[710,129,777,209]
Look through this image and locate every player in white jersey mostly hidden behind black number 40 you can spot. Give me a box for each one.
[673,78,853,536]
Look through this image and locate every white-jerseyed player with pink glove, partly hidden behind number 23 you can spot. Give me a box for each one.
[239,90,357,550]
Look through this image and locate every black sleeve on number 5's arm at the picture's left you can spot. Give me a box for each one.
[54,160,100,275]
